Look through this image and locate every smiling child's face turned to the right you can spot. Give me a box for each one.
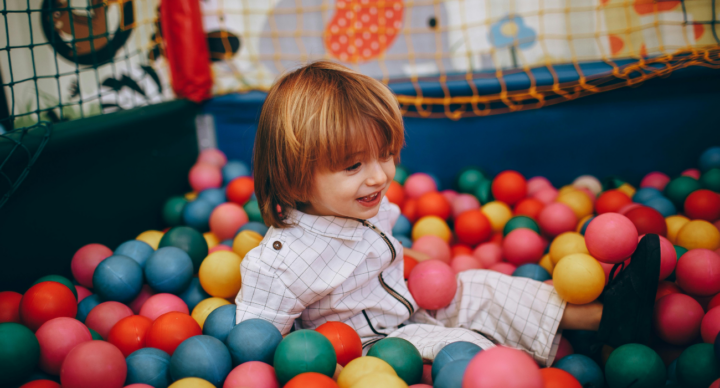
[303,156,395,220]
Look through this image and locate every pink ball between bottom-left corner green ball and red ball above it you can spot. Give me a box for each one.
[35,317,92,375]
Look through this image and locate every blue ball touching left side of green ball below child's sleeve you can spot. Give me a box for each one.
[225,318,282,366]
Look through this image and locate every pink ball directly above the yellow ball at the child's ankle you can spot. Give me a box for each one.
[585,213,640,264]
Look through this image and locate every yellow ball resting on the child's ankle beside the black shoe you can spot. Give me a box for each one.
[553,253,605,304]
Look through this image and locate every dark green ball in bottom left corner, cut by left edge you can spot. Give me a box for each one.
[0,322,40,386]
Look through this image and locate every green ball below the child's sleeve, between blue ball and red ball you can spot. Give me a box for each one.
[273,330,337,386]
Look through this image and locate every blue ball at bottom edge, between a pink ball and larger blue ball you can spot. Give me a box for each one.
[125,348,172,388]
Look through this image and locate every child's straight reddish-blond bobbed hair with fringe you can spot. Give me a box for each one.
[253,61,405,228]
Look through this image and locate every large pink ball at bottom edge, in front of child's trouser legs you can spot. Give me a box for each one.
[462,346,545,388]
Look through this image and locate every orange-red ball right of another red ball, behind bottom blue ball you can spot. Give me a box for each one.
[145,311,202,356]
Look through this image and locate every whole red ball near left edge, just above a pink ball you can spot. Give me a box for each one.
[20,282,77,331]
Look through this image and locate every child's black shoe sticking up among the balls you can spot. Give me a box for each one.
[598,234,660,348]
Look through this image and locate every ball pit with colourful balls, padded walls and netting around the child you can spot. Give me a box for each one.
[0,0,720,388]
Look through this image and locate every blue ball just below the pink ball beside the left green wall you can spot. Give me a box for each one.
[93,255,143,303]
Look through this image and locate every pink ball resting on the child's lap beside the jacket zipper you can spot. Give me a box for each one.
[408,260,457,310]
